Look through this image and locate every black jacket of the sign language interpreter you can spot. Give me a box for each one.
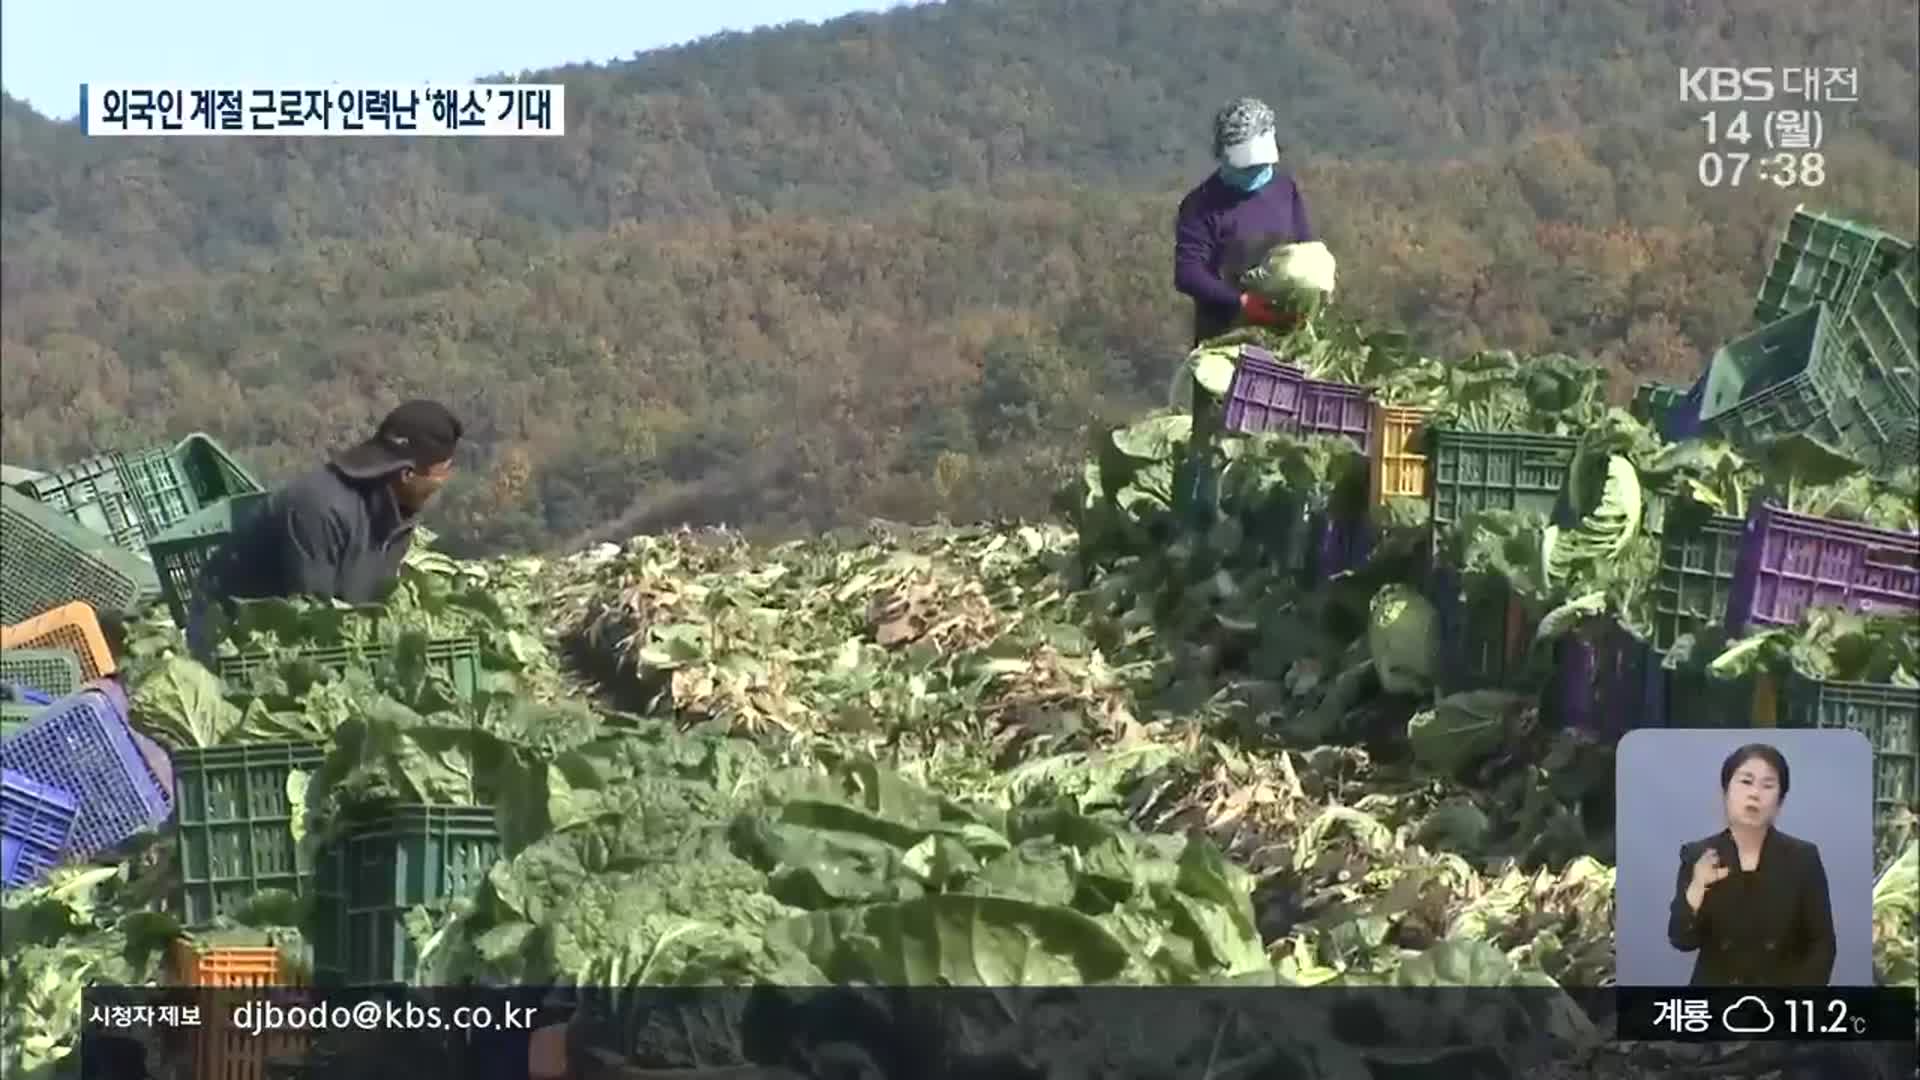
[1667,828,1834,986]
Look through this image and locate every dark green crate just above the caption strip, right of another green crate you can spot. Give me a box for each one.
[311,805,499,986]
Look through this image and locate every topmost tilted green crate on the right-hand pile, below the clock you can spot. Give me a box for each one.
[1753,204,1912,325]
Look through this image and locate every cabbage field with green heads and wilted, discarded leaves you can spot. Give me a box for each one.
[0,297,1920,1078]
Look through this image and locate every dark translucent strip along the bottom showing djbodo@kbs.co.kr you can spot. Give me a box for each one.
[81,986,1916,1080]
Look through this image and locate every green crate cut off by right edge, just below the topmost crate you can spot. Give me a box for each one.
[1826,252,1920,467]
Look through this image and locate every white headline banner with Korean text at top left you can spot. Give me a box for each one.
[81,83,566,138]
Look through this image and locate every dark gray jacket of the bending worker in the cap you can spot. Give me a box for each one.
[200,465,413,603]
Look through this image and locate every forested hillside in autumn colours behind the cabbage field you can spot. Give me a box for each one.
[0,0,1920,550]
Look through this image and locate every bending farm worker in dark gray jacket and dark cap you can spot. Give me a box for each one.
[186,402,463,663]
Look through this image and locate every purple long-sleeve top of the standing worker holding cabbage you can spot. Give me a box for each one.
[1173,173,1313,342]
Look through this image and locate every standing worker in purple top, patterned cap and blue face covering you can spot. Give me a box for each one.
[1173,98,1313,346]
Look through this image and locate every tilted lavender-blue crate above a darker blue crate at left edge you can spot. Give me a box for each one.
[0,678,173,859]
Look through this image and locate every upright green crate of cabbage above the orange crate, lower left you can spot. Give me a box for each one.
[173,742,326,926]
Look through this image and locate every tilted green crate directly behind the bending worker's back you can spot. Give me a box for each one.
[19,432,261,552]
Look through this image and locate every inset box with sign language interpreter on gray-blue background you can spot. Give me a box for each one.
[1615,728,1874,988]
